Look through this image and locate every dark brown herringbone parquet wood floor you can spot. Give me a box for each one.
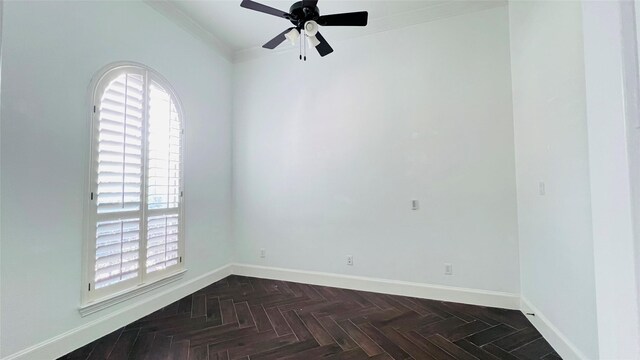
[61,276,560,360]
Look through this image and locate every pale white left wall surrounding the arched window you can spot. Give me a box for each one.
[0,1,232,356]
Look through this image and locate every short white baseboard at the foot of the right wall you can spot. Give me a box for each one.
[520,297,589,360]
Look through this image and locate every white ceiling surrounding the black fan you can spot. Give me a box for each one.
[147,0,506,61]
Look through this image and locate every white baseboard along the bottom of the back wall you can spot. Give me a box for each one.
[232,264,520,310]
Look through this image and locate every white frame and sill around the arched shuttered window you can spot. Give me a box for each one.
[80,62,186,310]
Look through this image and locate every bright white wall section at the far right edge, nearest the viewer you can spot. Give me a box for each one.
[582,1,640,359]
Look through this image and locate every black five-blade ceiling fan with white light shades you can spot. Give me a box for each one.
[240,0,369,61]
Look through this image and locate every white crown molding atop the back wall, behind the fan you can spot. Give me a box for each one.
[233,0,508,63]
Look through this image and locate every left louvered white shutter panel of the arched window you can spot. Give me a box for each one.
[94,73,144,289]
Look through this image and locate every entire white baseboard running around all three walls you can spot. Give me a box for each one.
[2,264,587,360]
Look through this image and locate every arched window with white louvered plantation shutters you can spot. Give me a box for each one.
[85,65,184,301]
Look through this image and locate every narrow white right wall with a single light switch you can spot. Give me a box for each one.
[509,1,598,359]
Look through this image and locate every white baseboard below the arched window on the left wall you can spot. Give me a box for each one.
[2,265,232,360]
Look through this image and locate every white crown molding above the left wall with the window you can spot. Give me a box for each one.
[143,0,234,62]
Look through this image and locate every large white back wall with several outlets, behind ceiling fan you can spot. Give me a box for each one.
[233,7,519,293]
